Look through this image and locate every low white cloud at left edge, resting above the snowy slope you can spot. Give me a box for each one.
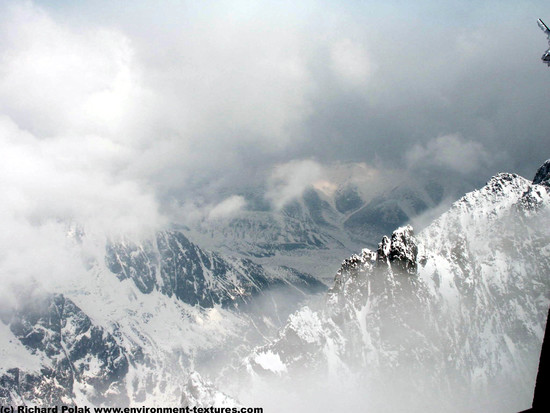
[0,117,163,238]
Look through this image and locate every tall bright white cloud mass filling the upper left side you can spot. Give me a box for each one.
[0,2,164,238]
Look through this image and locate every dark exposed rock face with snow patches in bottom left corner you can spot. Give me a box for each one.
[0,295,129,406]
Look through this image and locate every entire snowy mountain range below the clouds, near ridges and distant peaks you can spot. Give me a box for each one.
[0,161,550,411]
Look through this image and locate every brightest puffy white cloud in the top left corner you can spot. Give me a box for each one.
[0,3,144,138]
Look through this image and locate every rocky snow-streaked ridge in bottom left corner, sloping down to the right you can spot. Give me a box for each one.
[0,294,237,406]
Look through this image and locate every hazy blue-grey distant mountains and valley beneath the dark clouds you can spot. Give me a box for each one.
[188,179,464,282]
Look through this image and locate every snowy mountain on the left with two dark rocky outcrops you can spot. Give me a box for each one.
[0,229,326,406]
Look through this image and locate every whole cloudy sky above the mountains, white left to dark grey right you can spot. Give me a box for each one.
[0,0,550,237]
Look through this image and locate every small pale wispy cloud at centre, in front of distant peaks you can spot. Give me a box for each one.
[266,159,323,209]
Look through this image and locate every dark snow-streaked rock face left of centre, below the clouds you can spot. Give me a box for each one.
[106,231,325,308]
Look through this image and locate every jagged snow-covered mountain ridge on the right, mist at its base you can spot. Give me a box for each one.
[238,161,550,412]
